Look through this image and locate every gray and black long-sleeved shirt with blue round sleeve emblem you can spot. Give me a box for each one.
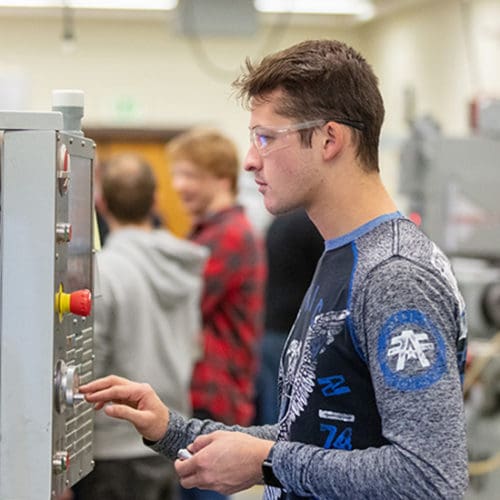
[154,213,468,500]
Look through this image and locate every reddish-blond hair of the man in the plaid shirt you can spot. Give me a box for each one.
[167,128,239,194]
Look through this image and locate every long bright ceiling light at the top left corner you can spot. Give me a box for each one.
[0,0,177,10]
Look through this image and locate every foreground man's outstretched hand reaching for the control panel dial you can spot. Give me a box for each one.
[79,375,169,441]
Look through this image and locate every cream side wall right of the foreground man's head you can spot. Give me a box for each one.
[360,0,500,209]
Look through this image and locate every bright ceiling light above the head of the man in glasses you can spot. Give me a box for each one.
[254,0,374,17]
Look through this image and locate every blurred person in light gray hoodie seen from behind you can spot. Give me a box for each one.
[74,154,207,500]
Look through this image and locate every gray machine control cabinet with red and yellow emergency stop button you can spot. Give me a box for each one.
[0,91,95,500]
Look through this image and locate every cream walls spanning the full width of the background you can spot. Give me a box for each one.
[0,0,500,222]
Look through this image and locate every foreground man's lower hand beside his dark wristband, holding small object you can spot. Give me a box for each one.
[175,431,274,495]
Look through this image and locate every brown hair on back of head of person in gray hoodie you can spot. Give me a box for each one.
[101,153,156,223]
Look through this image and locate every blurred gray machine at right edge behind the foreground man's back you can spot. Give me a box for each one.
[399,100,500,500]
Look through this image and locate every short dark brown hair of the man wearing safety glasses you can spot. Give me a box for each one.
[233,40,384,171]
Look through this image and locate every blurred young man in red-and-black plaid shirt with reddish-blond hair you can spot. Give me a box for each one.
[168,129,266,500]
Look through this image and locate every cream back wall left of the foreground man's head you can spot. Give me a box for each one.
[0,12,356,152]
